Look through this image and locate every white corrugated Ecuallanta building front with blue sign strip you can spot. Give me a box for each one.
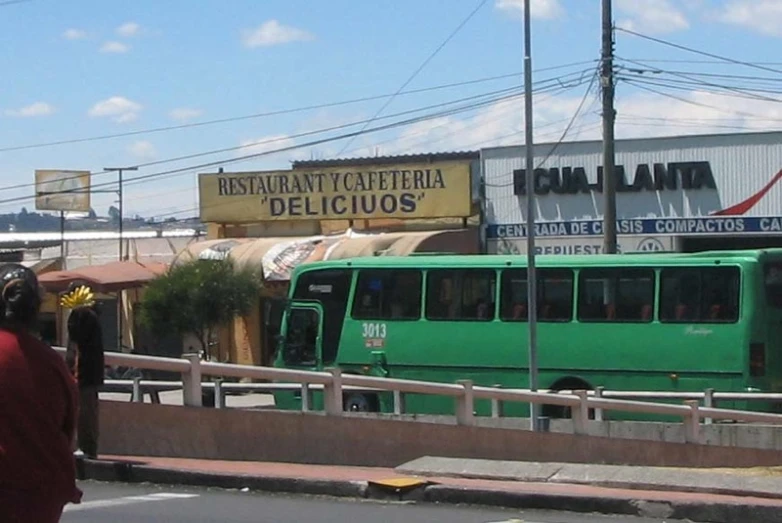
[481,132,782,254]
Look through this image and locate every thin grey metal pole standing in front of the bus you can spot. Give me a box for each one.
[524,0,540,432]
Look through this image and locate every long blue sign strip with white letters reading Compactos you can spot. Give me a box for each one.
[494,216,782,239]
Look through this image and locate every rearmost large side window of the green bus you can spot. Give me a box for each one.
[660,267,740,323]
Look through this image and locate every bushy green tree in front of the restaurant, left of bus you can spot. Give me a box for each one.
[141,259,262,356]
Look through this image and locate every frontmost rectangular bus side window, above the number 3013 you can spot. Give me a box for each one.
[353,269,422,320]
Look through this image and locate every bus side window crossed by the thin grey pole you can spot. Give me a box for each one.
[500,269,573,322]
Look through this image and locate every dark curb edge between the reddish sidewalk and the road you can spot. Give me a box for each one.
[76,458,782,523]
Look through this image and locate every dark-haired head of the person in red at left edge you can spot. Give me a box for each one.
[0,263,41,328]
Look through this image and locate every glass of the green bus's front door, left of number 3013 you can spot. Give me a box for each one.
[281,301,323,370]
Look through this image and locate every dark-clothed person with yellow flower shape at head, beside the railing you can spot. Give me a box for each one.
[62,282,105,459]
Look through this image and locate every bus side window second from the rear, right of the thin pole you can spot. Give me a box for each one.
[578,268,654,322]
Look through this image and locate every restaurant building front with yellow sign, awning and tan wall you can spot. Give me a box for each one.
[193,151,481,365]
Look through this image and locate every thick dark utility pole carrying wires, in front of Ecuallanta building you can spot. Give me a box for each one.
[600,0,616,254]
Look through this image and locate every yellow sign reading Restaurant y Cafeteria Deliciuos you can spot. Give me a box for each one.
[198,162,472,223]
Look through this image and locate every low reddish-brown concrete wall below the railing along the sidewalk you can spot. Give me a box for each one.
[101,401,782,467]
